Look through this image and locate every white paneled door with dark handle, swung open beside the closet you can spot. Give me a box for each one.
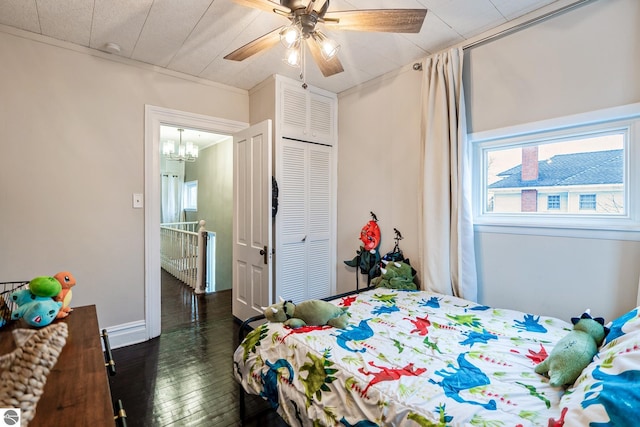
[232,120,272,320]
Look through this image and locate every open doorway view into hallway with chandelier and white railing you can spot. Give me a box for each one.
[160,124,233,293]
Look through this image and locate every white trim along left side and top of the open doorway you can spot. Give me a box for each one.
[144,104,249,339]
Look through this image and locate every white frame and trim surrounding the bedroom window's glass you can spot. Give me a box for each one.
[467,103,640,241]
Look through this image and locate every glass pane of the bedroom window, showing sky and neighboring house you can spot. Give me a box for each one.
[483,130,626,215]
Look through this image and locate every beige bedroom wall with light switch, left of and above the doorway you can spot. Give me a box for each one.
[0,32,249,328]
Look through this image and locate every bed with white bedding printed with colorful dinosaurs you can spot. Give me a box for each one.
[234,288,640,426]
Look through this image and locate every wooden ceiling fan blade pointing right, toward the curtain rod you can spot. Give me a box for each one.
[324,9,427,33]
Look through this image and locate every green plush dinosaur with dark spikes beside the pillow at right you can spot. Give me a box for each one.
[535,310,609,387]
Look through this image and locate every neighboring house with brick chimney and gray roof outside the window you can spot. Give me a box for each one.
[488,147,624,214]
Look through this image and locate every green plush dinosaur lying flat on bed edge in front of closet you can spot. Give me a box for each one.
[262,297,349,329]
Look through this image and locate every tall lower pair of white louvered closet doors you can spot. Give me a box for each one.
[275,138,332,302]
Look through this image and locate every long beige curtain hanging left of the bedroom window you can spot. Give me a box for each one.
[420,48,478,301]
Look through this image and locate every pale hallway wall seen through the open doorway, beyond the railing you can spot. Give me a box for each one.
[185,139,233,291]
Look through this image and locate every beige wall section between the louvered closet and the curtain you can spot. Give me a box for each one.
[337,69,422,298]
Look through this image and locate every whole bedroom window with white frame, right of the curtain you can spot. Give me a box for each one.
[469,104,640,237]
